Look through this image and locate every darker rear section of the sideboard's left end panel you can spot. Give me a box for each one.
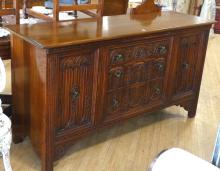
[11,35,30,143]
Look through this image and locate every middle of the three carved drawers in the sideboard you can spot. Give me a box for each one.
[108,58,166,91]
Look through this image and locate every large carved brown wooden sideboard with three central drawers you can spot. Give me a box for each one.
[7,12,213,171]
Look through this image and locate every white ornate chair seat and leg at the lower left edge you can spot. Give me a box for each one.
[0,99,12,171]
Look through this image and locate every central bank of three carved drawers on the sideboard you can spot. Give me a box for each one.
[104,39,170,121]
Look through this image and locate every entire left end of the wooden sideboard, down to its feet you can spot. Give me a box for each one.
[11,35,49,170]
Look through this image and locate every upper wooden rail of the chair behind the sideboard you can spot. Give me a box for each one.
[59,4,98,11]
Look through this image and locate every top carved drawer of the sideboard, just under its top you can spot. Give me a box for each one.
[109,39,170,66]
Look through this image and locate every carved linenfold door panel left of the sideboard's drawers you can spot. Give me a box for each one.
[55,54,94,133]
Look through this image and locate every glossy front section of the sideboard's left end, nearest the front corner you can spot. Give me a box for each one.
[27,45,48,157]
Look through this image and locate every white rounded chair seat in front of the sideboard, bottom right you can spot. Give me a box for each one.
[150,148,220,171]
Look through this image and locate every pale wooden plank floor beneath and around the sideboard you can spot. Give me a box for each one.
[0,35,220,171]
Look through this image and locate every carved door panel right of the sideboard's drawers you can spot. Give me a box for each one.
[174,35,199,95]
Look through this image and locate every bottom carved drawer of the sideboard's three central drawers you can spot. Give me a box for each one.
[105,79,164,117]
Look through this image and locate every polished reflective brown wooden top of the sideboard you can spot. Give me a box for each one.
[6,12,214,48]
